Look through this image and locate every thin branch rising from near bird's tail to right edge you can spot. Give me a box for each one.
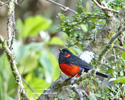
[96,26,125,67]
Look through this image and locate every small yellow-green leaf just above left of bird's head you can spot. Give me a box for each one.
[48,37,64,46]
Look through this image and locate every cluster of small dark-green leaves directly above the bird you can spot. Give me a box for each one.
[59,4,106,47]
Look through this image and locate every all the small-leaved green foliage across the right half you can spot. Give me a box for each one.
[59,0,125,100]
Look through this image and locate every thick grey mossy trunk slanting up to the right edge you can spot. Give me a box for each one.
[84,8,125,53]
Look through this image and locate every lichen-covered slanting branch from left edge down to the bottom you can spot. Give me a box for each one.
[0,36,28,100]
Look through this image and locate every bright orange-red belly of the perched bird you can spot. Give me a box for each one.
[59,64,80,77]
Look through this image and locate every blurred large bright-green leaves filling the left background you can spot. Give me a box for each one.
[0,15,64,100]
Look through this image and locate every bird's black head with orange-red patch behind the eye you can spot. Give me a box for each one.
[59,48,73,63]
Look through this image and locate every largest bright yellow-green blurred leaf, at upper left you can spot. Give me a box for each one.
[21,15,51,38]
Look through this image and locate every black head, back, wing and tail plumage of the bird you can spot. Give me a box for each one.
[59,48,108,78]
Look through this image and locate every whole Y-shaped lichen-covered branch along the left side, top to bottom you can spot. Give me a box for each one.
[0,0,28,100]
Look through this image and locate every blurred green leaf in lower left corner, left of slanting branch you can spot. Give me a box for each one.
[0,53,16,100]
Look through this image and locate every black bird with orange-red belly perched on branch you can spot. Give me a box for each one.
[58,48,108,78]
